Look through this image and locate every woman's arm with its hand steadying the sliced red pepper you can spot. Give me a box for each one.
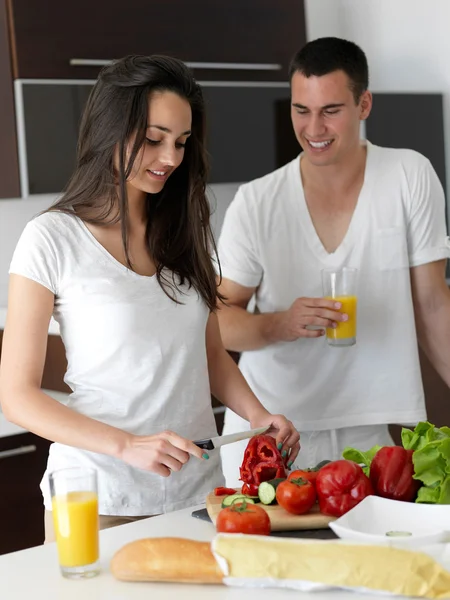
[206,313,300,461]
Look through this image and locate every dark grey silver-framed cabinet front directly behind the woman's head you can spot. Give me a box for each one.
[17,80,299,194]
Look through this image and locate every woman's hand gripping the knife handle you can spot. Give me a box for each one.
[119,431,209,477]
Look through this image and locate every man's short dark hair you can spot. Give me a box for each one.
[289,37,369,104]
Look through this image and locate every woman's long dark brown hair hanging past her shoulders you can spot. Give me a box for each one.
[49,56,223,311]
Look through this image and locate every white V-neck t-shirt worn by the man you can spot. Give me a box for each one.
[219,143,450,433]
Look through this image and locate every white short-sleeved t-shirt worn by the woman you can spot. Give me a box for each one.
[10,212,223,516]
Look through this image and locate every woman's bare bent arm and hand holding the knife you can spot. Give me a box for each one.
[0,275,206,475]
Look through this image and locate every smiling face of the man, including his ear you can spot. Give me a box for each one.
[291,71,372,166]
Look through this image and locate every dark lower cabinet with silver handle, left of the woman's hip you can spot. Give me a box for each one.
[0,433,50,554]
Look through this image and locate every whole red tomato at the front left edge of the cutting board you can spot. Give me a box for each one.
[216,501,270,535]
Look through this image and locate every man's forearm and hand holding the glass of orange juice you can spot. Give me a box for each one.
[217,278,348,352]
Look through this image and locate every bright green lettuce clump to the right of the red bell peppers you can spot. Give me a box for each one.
[402,421,450,504]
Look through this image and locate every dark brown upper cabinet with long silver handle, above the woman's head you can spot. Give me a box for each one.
[9,0,305,80]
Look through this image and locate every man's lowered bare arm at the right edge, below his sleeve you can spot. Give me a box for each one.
[411,260,450,387]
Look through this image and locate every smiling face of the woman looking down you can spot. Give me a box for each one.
[127,92,192,197]
